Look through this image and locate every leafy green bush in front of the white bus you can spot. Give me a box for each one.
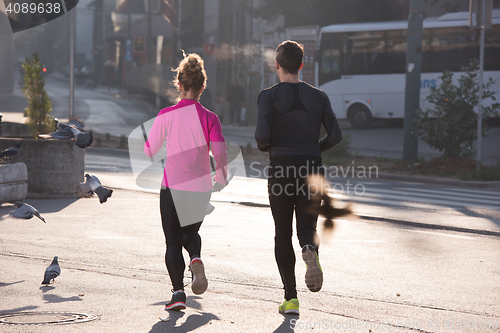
[415,59,500,158]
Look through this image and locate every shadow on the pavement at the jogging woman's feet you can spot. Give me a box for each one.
[149,311,220,333]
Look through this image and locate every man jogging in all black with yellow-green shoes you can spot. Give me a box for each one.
[255,41,342,314]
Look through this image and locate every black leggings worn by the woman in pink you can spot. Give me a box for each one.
[160,188,210,290]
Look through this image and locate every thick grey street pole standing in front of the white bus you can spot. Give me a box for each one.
[403,0,423,163]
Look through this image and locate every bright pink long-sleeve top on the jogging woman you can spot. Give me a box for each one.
[144,99,227,192]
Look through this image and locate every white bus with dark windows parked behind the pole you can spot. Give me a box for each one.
[315,9,500,128]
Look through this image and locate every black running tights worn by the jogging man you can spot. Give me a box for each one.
[268,156,322,300]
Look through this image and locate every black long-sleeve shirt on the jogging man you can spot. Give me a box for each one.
[255,82,342,158]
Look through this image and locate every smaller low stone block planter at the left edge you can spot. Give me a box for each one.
[0,163,28,204]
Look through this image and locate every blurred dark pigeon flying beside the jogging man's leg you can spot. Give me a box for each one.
[307,175,352,230]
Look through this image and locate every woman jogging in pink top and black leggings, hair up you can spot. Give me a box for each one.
[144,53,227,310]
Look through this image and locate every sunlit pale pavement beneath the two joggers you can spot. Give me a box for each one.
[0,172,500,333]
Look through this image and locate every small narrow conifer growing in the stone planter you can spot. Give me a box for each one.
[23,53,54,136]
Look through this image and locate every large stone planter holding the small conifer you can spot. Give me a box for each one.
[0,138,85,199]
